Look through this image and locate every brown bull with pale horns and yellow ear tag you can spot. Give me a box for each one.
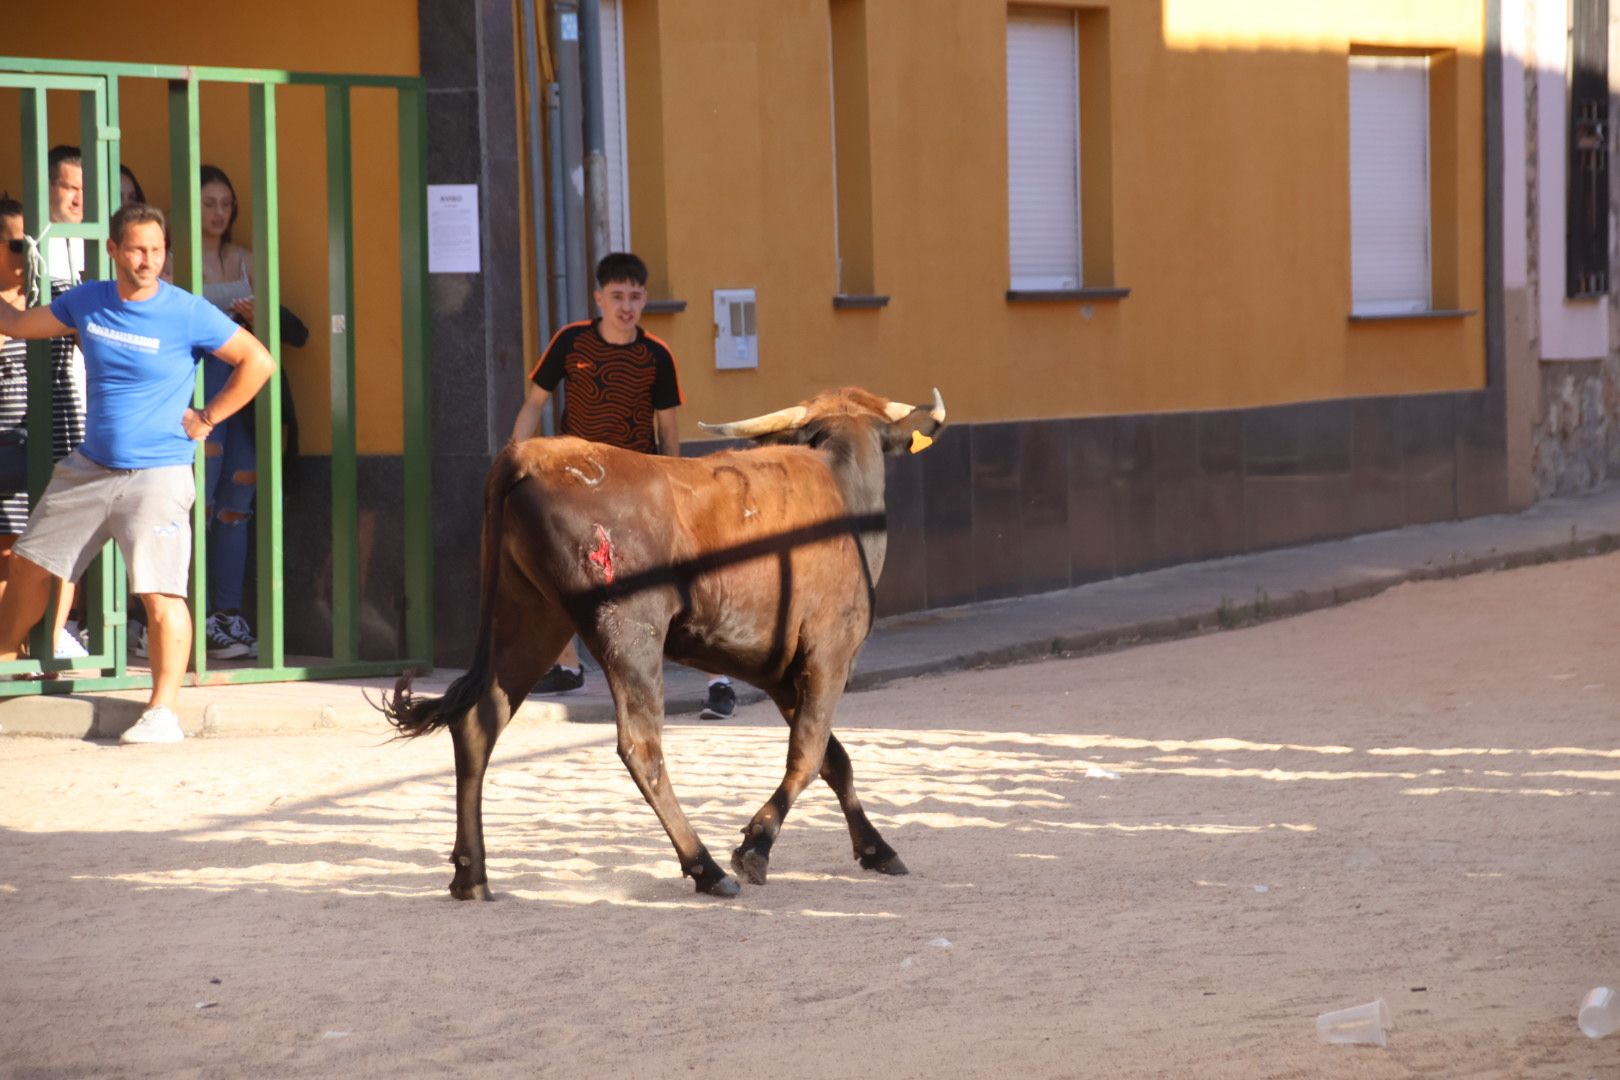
[382,389,944,900]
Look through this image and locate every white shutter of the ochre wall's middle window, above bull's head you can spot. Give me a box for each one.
[1006,8,1084,290]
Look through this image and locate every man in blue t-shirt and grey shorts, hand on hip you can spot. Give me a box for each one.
[0,202,275,743]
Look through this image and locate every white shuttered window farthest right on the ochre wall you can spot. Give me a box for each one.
[1349,55,1432,316]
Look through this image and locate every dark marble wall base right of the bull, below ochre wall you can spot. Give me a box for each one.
[878,390,1508,615]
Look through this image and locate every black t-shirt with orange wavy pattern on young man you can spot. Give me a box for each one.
[531,319,682,453]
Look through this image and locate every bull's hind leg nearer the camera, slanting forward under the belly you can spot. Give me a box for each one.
[591,663,742,897]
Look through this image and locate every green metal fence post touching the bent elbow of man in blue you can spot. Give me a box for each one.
[248,83,287,667]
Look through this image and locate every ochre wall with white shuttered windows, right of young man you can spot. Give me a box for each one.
[624,0,1484,436]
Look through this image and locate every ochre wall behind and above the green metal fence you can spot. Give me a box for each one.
[0,0,420,453]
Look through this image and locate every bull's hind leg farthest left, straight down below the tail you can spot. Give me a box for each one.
[450,605,573,900]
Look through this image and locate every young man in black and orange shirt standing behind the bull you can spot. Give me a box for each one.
[512,251,737,719]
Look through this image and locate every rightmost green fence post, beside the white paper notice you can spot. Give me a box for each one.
[399,89,433,664]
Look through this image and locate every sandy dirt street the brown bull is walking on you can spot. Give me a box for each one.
[0,555,1620,1080]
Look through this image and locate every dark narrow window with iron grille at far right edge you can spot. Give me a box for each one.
[1565,0,1609,300]
